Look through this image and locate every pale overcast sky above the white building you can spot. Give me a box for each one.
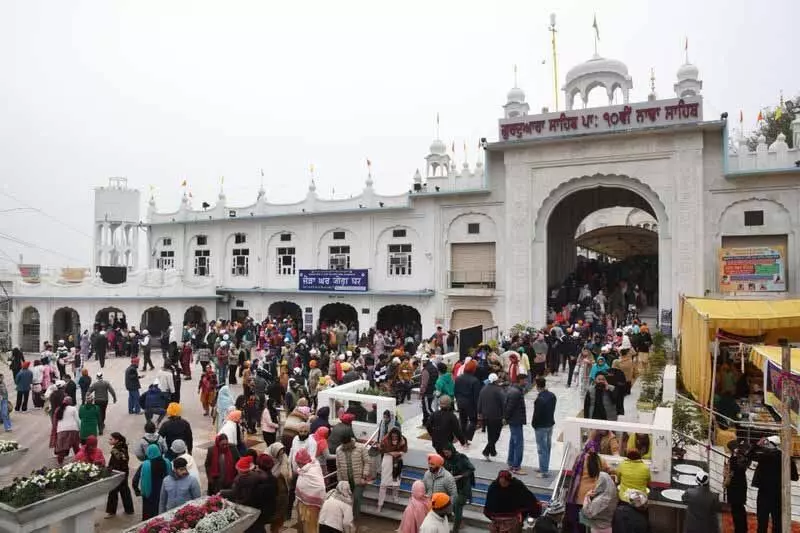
[0,0,800,267]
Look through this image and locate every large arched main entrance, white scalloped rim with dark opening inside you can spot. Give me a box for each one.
[533,175,671,322]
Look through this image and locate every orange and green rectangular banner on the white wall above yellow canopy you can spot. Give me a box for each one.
[719,246,786,292]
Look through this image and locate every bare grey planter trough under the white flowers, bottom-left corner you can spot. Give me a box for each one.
[0,472,125,533]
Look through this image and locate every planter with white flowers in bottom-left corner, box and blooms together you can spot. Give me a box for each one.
[0,463,125,533]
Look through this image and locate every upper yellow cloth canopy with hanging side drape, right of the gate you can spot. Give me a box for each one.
[680,297,800,405]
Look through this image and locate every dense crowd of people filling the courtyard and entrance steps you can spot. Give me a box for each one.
[0,296,792,533]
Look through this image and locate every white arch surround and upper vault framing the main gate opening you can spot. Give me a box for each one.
[531,174,674,325]
